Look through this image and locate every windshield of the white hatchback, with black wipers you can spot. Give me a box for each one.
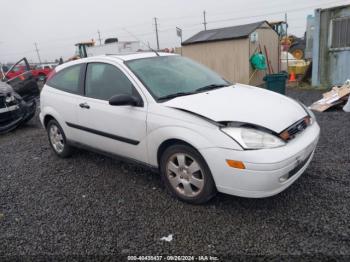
[126,56,230,101]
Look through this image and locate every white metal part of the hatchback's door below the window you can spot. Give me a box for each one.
[77,97,148,162]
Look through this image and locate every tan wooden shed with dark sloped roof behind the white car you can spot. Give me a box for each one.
[182,21,280,86]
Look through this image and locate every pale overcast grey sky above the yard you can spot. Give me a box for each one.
[0,0,350,63]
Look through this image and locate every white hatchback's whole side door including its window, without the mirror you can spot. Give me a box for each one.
[77,62,147,162]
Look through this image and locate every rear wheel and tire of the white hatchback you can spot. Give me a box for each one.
[46,119,72,158]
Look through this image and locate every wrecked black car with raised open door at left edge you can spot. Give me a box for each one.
[0,58,40,134]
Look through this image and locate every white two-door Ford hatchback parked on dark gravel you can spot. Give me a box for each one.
[40,52,320,204]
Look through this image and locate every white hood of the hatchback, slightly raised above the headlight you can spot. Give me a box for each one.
[163,84,307,133]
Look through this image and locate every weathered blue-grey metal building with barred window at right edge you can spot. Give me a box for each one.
[312,5,350,87]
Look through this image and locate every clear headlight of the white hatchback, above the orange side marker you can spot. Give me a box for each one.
[221,127,286,149]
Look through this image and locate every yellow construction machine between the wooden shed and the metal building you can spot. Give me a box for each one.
[269,21,306,60]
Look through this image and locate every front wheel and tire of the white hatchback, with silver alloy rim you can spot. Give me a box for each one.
[160,144,216,204]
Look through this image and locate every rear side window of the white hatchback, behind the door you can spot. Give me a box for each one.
[47,65,82,93]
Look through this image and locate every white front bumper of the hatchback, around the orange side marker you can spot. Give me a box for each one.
[200,122,320,198]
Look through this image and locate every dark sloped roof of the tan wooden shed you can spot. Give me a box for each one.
[182,21,272,45]
